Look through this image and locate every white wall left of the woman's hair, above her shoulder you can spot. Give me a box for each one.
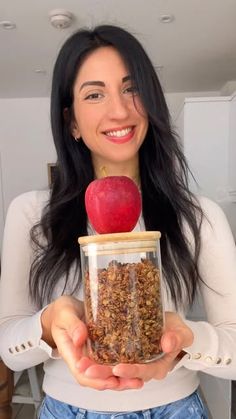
[0,98,55,220]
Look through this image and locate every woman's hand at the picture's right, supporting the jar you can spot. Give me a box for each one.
[81,312,193,381]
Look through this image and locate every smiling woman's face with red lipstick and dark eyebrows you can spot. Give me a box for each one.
[72,47,148,171]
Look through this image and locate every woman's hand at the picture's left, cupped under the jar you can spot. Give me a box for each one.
[41,296,143,390]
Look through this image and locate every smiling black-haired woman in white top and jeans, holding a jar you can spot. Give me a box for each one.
[0,26,236,419]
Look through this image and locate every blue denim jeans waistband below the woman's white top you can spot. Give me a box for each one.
[39,391,208,419]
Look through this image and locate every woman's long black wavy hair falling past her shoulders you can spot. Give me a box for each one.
[30,25,202,307]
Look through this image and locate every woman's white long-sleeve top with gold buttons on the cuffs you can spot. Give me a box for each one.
[0,191,236,411]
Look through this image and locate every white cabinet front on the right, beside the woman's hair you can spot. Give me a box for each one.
[179,98,230,200]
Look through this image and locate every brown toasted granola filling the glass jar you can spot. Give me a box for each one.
[85,259,163,364]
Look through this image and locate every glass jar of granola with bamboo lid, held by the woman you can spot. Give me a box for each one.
[79,231,163,365]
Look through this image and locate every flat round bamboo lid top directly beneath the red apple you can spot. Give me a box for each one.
[78,231,161,245]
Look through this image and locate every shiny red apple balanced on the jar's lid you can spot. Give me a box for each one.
[85,176,141,234]
